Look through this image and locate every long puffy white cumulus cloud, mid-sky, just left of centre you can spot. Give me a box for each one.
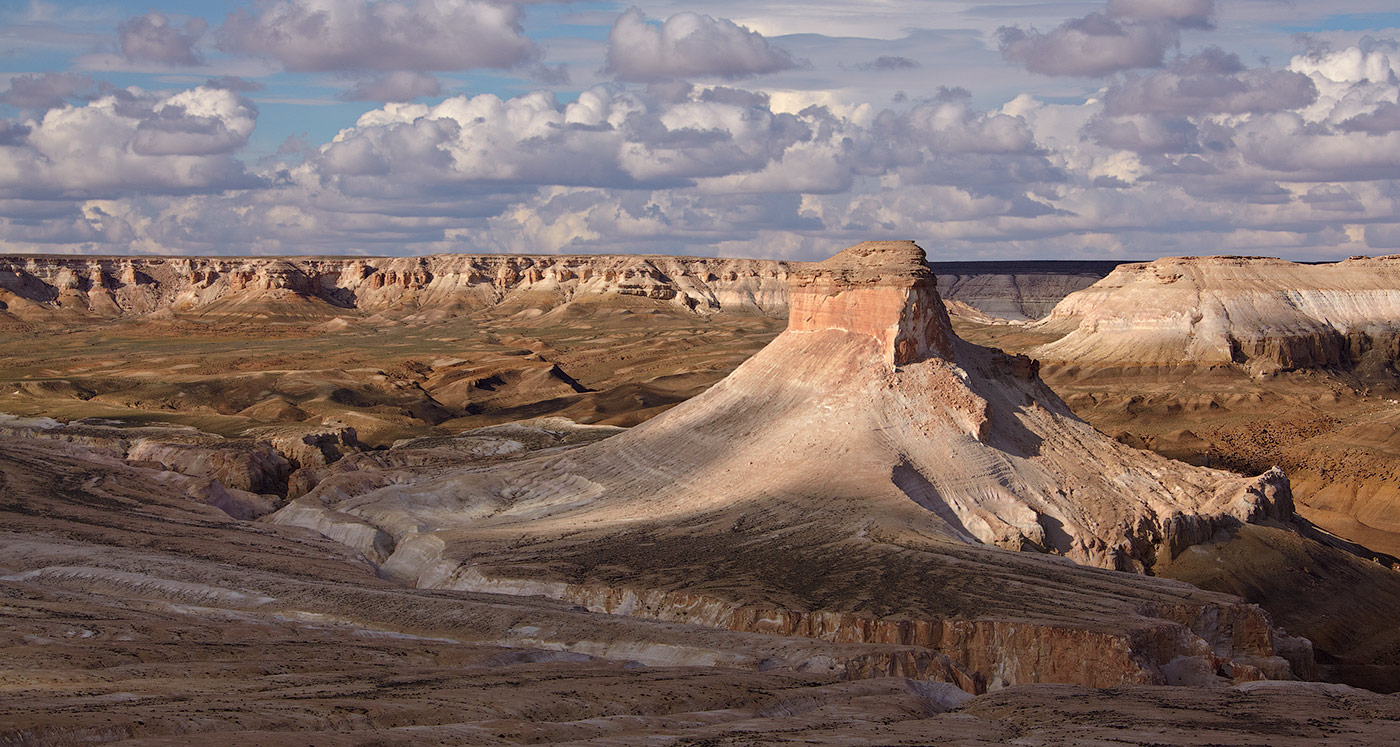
[306,88,809,189]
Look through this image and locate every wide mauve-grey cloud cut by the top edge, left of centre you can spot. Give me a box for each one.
[218,0,539,71]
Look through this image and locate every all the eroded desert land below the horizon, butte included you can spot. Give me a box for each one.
[0,242,1400,744]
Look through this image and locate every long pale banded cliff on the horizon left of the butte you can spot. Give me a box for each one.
[0,255,787,320]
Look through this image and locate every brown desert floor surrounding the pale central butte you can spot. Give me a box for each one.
[0,251,1400,746]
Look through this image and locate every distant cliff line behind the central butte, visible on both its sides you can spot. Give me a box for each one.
[0,255,1116,327]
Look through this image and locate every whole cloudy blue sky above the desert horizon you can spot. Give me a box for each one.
[0,0,1400,260]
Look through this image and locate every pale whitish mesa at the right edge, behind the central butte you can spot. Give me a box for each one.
[1033,256,1400,376]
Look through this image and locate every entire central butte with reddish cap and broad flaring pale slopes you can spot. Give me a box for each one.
[273,242,1309,688]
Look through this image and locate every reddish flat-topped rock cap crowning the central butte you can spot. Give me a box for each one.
[788,241,953,365]
